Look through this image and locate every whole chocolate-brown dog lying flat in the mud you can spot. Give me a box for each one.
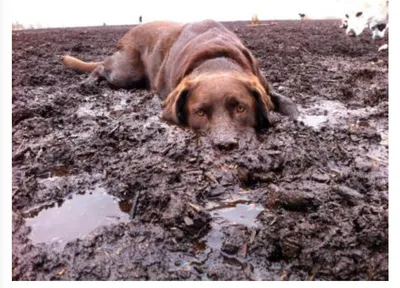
[63,20,298,149]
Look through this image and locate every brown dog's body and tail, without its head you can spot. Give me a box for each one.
[63,20,259,98]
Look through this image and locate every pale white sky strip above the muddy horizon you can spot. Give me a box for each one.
[10,0,354,27]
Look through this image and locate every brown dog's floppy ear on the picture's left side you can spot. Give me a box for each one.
[161,79,189,125]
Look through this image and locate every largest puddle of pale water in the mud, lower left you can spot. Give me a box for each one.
[26,188,130,249]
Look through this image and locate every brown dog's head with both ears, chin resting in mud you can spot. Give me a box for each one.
[162,72,290,150]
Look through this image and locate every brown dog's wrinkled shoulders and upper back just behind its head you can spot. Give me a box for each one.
[156,20,257,96]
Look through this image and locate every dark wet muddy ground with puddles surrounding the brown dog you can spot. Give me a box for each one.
[12,21,389,280]
